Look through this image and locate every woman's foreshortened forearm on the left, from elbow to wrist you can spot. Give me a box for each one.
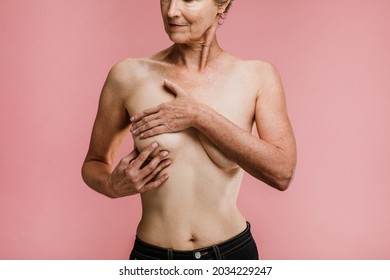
[81,160,113,198]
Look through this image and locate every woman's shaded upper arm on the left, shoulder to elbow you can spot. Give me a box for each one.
[85,61,130,166]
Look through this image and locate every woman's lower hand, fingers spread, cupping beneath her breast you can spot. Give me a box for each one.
[107,142,171,197]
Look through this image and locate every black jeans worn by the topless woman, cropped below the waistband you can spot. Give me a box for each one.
[130,222,259,260]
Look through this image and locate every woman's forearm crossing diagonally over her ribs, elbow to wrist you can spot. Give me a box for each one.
[194,105,295,190]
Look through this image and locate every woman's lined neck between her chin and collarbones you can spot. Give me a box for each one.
[170,15,222,72]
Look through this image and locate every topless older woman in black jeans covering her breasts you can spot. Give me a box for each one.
[82,0,296,259]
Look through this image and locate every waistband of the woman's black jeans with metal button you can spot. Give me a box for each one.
[133,222,253,260]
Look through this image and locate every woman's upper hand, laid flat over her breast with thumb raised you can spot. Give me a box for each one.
[131,80,200,138]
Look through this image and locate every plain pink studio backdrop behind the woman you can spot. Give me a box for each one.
[0,0,390,259]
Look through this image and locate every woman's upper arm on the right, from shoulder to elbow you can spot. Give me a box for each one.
[255,63,296,165]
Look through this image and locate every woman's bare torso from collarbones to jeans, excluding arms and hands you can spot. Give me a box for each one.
[124,53,258,250]
